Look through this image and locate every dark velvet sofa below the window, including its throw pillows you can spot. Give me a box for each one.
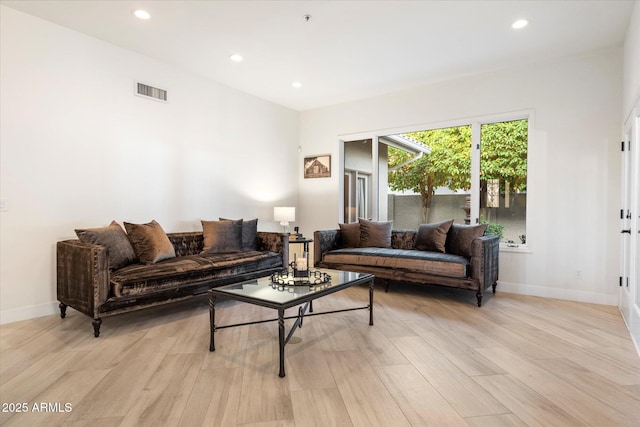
[314,220,500,307]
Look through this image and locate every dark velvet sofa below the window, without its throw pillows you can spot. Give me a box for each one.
[314,221,500,307]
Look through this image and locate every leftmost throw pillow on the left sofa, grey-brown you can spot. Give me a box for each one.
[75,221,136,270]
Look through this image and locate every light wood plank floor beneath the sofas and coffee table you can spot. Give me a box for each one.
[0,285,640,427]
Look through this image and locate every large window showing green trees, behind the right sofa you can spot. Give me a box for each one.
[344,114,529,247]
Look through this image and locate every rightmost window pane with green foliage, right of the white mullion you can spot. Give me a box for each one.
[480,119,528,245]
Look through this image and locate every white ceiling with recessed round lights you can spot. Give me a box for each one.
[1,0,634,111]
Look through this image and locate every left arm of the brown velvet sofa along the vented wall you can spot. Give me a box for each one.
[56,240,109,319]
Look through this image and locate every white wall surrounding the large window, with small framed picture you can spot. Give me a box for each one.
[299,49,622,305]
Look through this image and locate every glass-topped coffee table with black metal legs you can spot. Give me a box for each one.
[209,269,374,377]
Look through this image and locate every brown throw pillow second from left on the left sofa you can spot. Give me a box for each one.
[124,219,176,264]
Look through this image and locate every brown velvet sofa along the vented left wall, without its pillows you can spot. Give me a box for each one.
[56,227,289,337]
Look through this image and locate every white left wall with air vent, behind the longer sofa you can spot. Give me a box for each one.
[0,6,299,323]
